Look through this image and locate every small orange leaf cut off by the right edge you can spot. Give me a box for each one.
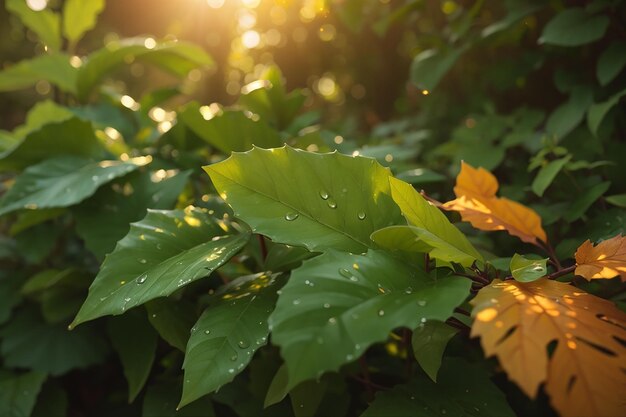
[575,235,626,281]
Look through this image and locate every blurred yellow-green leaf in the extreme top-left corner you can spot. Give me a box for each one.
[5,0,61,51]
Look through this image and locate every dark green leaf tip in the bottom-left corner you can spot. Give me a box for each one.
[0,370,47,417]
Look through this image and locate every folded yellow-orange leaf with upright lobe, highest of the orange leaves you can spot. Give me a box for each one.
[442,162,547,243]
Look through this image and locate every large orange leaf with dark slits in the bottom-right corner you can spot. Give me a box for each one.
[471,279,626,416]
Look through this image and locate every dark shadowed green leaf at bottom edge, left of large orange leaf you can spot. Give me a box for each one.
[361,358,515,417]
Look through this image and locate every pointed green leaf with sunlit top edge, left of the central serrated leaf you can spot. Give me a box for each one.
[71,206,249,327]
